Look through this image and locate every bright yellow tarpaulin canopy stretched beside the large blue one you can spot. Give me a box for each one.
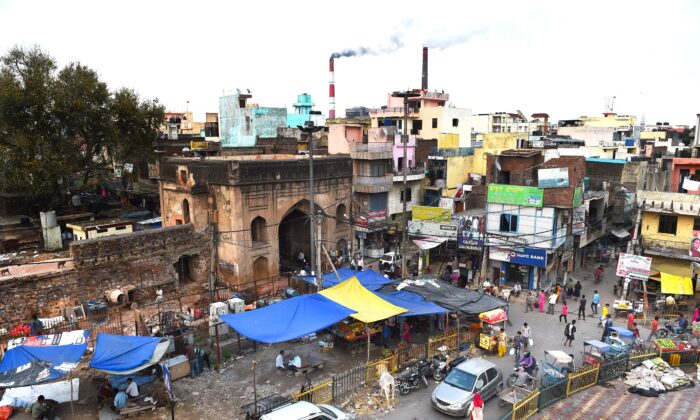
[319,276,408,322]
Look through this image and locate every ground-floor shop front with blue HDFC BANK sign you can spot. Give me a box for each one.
[489,247,547,289]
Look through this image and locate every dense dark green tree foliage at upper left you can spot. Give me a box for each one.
[0,47,164,209]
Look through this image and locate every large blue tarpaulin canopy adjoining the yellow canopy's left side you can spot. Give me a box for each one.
[220,293,355,343]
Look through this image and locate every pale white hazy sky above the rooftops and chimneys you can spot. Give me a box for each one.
[0,0,700,125]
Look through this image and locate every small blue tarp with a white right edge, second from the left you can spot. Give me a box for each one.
[90,334,168,375]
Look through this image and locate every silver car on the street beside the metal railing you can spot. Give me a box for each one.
[431,358,503,417]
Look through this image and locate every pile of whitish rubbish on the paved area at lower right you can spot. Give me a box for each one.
[625,357,695,397]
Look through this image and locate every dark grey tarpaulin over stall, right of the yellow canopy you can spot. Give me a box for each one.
[380,277,508,318]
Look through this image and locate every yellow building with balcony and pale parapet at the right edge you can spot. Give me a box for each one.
[637,191,700,294]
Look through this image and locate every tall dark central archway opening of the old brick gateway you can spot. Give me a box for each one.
[278,208,311,272]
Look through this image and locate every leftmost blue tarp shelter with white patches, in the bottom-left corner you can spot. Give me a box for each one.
[0,330,90,388]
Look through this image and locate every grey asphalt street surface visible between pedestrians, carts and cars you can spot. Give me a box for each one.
[384,263,648,420]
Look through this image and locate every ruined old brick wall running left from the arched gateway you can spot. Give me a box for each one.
[0,224,209,329]
